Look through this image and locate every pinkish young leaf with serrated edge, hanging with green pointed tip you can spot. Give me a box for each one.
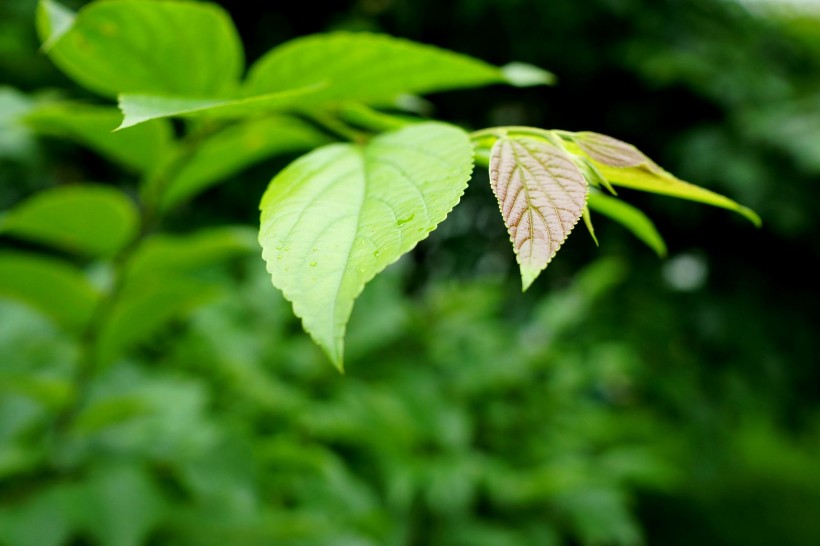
[490,137,588,290]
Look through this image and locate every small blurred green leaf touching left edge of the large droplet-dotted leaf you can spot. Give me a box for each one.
[125,227,258,283]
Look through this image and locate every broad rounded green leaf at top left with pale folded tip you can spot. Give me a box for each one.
[37,0,243,97]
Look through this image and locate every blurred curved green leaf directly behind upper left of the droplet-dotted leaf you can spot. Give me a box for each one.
[155,116,329,208]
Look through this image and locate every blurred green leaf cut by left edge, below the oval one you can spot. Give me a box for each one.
[0,251,99,333]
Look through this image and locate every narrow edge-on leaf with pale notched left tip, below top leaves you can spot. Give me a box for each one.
[117,84,323,130]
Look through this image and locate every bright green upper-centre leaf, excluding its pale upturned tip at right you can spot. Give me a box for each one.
[246,32,524,105]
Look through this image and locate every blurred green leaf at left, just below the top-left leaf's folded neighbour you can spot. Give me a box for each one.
[24,103,173,172]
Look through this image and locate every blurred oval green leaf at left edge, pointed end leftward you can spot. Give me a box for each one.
[0,186,139,256]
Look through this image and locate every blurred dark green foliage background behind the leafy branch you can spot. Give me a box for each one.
[0,0,820,546]
